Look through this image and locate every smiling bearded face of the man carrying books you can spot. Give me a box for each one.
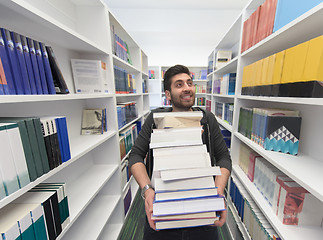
[165,73,195,111]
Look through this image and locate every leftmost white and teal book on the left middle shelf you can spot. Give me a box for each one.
[0,124,19,195]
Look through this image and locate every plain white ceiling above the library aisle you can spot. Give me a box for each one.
[104,0,249,66]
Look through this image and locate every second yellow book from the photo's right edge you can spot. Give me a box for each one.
[289,41,309,83]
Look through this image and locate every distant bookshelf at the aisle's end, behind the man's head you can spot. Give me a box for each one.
[148,66,208,109]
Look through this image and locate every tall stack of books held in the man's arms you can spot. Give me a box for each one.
[150,112,225,229]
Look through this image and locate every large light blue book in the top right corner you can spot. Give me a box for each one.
[273,0,322,32]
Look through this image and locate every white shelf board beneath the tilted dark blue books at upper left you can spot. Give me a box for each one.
[0,93,113,103]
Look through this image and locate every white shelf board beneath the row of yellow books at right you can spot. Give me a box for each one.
[237,95,323,106]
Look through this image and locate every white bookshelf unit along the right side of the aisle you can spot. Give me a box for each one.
[207,0,323,239]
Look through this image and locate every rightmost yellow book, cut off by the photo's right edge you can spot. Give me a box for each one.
[302,35,323,81]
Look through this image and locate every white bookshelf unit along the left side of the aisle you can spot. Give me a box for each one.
[0,0,150,239]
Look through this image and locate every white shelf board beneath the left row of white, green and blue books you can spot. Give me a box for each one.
[0,131,116,209]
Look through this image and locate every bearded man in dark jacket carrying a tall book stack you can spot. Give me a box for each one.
[129,65,232,240]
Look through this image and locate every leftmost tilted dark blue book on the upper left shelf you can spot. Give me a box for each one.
[0,31,16,94]
